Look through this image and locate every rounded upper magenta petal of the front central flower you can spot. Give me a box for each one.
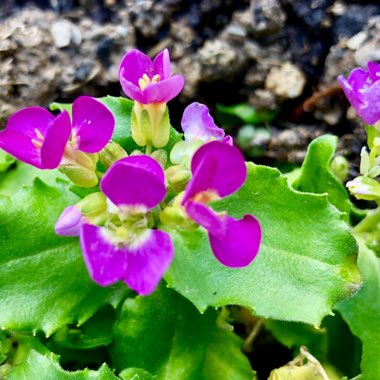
[100,155,166,208]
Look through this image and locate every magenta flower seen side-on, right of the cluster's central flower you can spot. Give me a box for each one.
[182,141,261,267]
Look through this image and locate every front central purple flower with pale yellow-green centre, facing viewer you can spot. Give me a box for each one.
[80,156,174,295]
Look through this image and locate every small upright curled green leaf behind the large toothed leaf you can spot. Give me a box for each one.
[292,135,351,218]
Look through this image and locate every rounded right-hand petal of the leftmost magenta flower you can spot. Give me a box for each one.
[73,96,115,153]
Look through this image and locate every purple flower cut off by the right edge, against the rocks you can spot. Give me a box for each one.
[338,62,380,125]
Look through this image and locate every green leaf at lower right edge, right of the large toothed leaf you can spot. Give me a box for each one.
[336,240,380,380]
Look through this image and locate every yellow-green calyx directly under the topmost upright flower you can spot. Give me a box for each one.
[131,101,170,148]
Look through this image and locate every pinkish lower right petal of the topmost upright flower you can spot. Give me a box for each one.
[141,74,185,104]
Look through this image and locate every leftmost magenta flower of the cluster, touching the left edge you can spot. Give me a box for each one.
[0,96,115,169]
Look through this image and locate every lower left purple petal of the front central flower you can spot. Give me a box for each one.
[80,224,128,286]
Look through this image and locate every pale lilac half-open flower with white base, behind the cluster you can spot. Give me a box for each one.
[181,102,232,145]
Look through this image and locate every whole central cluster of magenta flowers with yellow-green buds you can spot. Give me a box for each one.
[0,50,261,295]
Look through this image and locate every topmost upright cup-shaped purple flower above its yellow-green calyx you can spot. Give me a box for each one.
[119,49,185,104]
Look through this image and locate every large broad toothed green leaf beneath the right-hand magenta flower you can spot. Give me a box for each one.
[165,164,360,325]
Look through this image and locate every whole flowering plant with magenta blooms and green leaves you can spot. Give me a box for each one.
[0,49,380,380]
